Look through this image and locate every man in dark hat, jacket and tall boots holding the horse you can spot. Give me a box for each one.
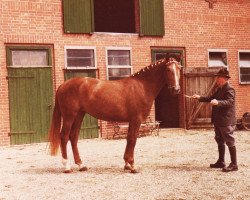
[192,68,238,172]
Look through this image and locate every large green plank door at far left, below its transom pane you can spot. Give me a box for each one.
[7,67,53,144]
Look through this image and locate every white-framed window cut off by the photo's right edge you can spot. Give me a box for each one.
[239,51,250,84]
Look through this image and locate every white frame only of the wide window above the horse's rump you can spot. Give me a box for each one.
[64,46,97,69]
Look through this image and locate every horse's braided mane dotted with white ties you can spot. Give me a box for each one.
[131,58,177,77]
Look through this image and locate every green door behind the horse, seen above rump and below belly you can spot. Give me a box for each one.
[65,70,98,139]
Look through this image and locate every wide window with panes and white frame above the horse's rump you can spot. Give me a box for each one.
[65,46,96,69]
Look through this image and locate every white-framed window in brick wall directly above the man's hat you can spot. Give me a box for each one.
[208,49,227,67]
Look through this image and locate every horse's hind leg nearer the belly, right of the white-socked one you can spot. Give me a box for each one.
[69,112,88,171]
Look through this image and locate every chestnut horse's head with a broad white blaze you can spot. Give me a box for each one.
[166,58,181,95]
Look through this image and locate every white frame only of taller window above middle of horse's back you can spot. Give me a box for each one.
[106,47,133,80]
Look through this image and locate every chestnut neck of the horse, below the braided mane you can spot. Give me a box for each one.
[133,64,166,99]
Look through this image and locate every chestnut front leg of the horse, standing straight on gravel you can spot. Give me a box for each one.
[124,122,141,173]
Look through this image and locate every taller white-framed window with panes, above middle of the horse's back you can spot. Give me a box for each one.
[107,48,132,80]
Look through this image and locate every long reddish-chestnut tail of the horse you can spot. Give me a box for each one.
[49,92,61,156]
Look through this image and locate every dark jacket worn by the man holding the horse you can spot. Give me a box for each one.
[199,82,236,127]
